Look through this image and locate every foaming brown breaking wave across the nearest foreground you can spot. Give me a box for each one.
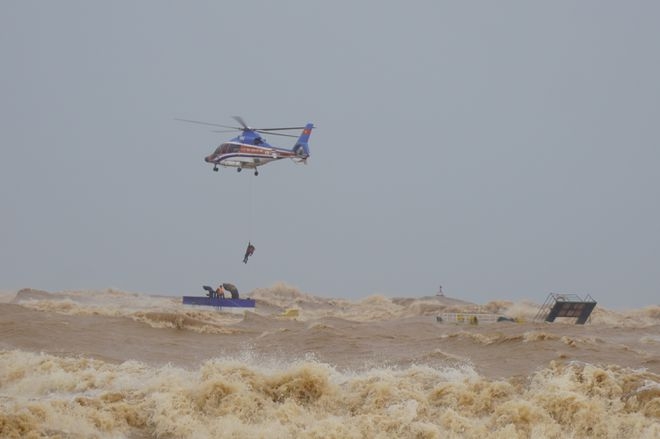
[0,351,660,439]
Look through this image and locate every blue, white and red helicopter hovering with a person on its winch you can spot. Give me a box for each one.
[176,116,315,175]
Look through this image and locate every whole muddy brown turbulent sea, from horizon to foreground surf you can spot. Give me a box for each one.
[0,284,660,439]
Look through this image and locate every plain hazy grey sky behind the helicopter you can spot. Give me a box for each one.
[0,1,660,308]
